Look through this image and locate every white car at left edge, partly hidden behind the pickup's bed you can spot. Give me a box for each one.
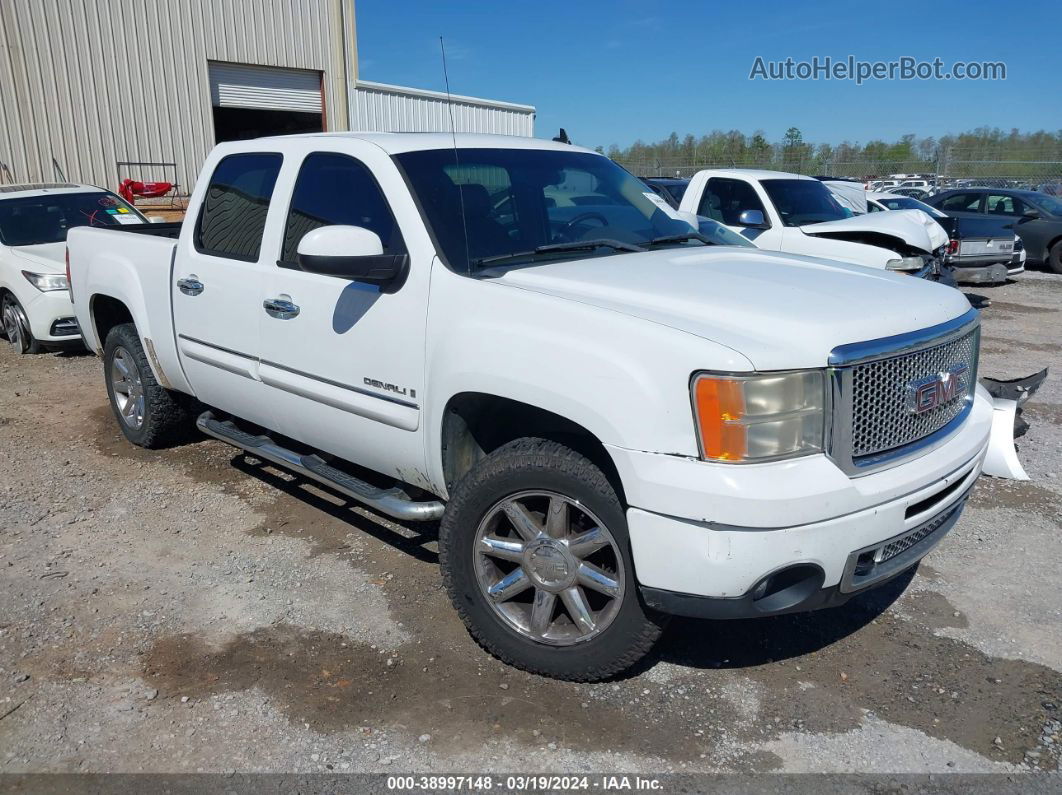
[0,183,148,353]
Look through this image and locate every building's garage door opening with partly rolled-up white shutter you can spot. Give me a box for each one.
[208,61,324,143]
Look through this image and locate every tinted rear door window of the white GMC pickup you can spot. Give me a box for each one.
[193,152,284,262]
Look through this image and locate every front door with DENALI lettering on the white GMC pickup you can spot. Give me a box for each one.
[258,145,434,485]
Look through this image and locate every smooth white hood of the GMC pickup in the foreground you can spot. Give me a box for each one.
[496,246,970,370]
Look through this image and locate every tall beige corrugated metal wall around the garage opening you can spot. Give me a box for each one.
[0,0,346,190]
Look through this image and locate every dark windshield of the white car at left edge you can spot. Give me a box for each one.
[0,191,145,245]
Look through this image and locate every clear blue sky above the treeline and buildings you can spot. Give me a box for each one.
[356,0,1062,146]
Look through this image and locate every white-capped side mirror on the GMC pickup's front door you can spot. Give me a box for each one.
[296,224,409,293]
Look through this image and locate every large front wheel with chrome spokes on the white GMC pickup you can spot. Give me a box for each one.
[439,438,664,681]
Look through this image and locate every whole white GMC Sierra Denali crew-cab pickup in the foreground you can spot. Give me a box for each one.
[69,134,992,680]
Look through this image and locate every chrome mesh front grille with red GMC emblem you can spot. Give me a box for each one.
[826,309,980,476]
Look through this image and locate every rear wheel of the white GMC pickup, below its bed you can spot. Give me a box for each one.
[103,323,189,450]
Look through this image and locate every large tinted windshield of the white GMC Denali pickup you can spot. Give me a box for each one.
[395,149,704,273]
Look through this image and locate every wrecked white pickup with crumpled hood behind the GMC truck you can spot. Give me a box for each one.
[680,169,948,281]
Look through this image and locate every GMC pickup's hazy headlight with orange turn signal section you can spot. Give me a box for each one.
[690,370,825,463]
